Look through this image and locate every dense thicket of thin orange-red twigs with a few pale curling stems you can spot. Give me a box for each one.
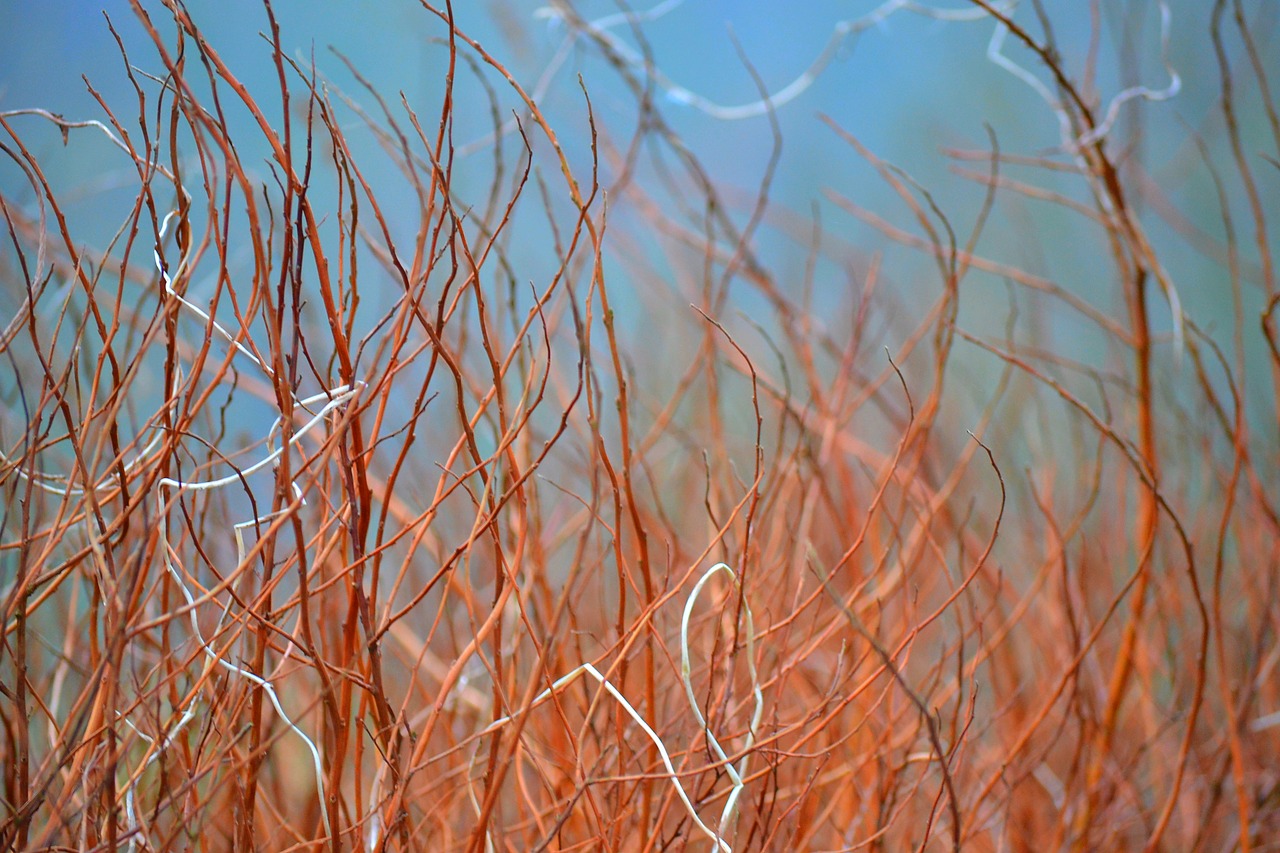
[0,0,1280,850]
